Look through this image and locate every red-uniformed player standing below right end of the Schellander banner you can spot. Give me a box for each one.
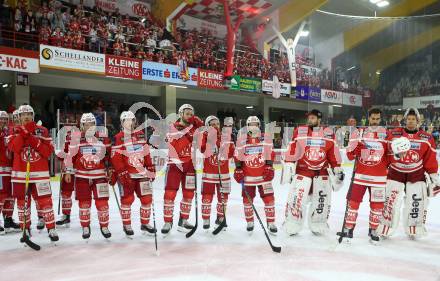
[65,113,111,239]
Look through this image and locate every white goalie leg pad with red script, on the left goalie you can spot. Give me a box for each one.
[284,175,312,235]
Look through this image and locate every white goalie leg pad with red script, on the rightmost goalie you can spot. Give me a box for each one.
[377,180,405,237]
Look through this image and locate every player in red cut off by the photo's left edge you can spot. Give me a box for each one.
[0,111,20,235]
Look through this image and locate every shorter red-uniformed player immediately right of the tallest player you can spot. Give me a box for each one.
[200,115,235,229]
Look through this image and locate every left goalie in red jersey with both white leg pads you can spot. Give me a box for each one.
[282,109,344,235]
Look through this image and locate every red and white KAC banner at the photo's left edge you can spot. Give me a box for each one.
[0,47,40,73]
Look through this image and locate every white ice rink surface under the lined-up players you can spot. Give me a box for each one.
[0,165,440,281]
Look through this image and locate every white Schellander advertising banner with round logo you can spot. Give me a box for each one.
[40,45,105,74]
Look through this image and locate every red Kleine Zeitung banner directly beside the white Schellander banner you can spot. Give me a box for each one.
[105,55,142,80]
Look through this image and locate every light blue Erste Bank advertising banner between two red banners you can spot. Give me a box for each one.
[142,61,197,86]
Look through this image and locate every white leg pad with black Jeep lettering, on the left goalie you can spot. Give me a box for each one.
[308,176,332,234]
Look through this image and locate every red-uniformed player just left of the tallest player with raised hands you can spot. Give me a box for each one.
[111,111,156,236]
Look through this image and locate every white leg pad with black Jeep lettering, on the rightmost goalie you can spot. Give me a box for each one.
[403,181,429,238]
